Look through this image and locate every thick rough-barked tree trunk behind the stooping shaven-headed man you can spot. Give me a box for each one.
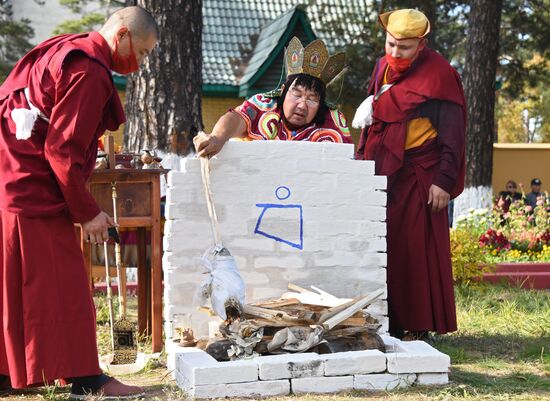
[124,0,203,155]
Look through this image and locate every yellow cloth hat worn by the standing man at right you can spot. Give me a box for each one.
[378,8,430,40]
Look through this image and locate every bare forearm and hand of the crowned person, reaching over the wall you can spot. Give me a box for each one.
[193,112,246,157]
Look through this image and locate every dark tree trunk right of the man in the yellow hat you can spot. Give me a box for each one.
[463,0,502,187]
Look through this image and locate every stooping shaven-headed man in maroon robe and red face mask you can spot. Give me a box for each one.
[0,7,157,399]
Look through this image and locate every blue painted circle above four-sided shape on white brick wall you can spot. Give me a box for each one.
[254,186,304,249]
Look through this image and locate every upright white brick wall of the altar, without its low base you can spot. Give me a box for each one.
[163,141,387,337]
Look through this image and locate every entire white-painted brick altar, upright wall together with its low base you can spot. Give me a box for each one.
[163,141,450,398]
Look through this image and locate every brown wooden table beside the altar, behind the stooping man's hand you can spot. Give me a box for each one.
[81,169,165,352]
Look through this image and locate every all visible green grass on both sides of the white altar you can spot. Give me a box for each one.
[9,286,550,401]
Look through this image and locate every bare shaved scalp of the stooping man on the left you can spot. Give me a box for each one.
[100,6,158,38]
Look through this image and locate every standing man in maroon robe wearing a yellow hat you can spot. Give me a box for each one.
[354,9,466,339]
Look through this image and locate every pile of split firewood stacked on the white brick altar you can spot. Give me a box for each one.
[203,284,384,361]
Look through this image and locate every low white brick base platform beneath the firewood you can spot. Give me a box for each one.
[167,336,450,398]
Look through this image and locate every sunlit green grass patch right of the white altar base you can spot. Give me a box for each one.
[426,286,550,400]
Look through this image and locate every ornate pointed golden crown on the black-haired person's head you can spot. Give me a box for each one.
[286,36,346,85]
